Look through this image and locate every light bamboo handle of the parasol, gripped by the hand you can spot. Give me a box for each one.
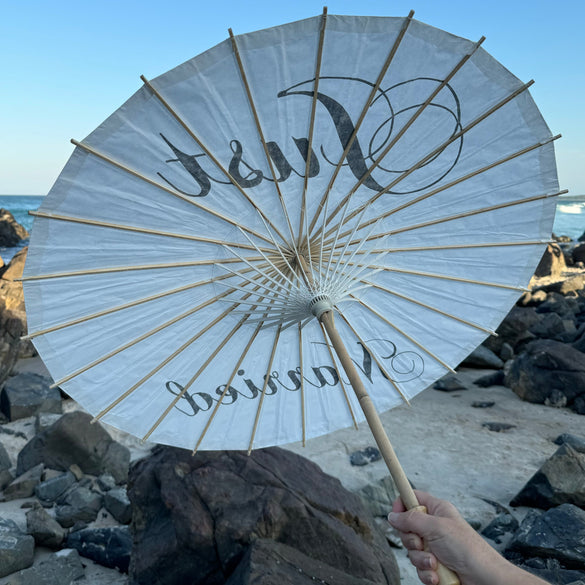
[319,311,459,585]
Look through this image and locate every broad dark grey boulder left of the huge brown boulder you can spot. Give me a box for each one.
[17,411,130,483]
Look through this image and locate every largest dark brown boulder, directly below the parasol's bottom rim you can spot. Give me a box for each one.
[128,447,400,585]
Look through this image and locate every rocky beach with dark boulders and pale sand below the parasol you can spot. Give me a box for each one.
[0,208,585,585]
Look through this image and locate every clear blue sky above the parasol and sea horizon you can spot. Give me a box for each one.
[0,0,585,195]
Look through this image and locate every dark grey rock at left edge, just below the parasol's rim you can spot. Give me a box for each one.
[0,373,61,421]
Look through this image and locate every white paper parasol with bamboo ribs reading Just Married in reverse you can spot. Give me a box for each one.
[23,12,559,580]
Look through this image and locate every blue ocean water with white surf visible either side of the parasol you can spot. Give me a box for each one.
[0,195,585,264]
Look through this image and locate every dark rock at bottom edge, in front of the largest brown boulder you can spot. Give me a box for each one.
[225,538,376,585]
